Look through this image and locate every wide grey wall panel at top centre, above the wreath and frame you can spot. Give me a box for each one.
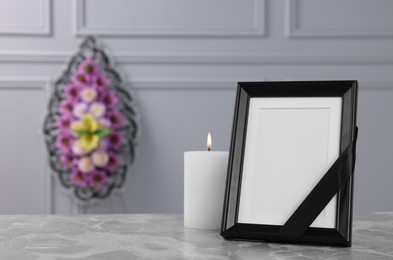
[74,0,265,37]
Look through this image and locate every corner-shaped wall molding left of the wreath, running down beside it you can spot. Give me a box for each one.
[0,77,52,214]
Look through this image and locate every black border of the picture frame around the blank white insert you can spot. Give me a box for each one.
[221,80,358,247]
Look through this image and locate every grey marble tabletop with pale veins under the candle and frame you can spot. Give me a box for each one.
[0,213,393,260]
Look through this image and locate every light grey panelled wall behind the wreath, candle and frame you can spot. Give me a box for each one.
[0,0,393,214]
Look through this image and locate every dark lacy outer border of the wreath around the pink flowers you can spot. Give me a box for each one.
[43,36,140,205]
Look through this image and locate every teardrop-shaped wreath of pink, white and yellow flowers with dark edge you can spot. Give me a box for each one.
[44,37,139,204]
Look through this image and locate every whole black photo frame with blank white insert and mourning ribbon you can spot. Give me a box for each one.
[221,81,358,246]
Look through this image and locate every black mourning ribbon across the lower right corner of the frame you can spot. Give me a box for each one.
[278,127,358,237]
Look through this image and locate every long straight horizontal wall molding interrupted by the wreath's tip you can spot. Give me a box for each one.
[0,52,393,65]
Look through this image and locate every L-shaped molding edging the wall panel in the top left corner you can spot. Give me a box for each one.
[0,0,51,36]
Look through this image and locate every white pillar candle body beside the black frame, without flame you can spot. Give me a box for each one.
[184,133,228,229]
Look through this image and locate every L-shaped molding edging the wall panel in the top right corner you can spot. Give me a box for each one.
[285,0,393,38]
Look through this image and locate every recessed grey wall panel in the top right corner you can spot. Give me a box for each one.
[286,0,393,38]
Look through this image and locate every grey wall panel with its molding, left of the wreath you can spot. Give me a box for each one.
[0,78,51,214]
